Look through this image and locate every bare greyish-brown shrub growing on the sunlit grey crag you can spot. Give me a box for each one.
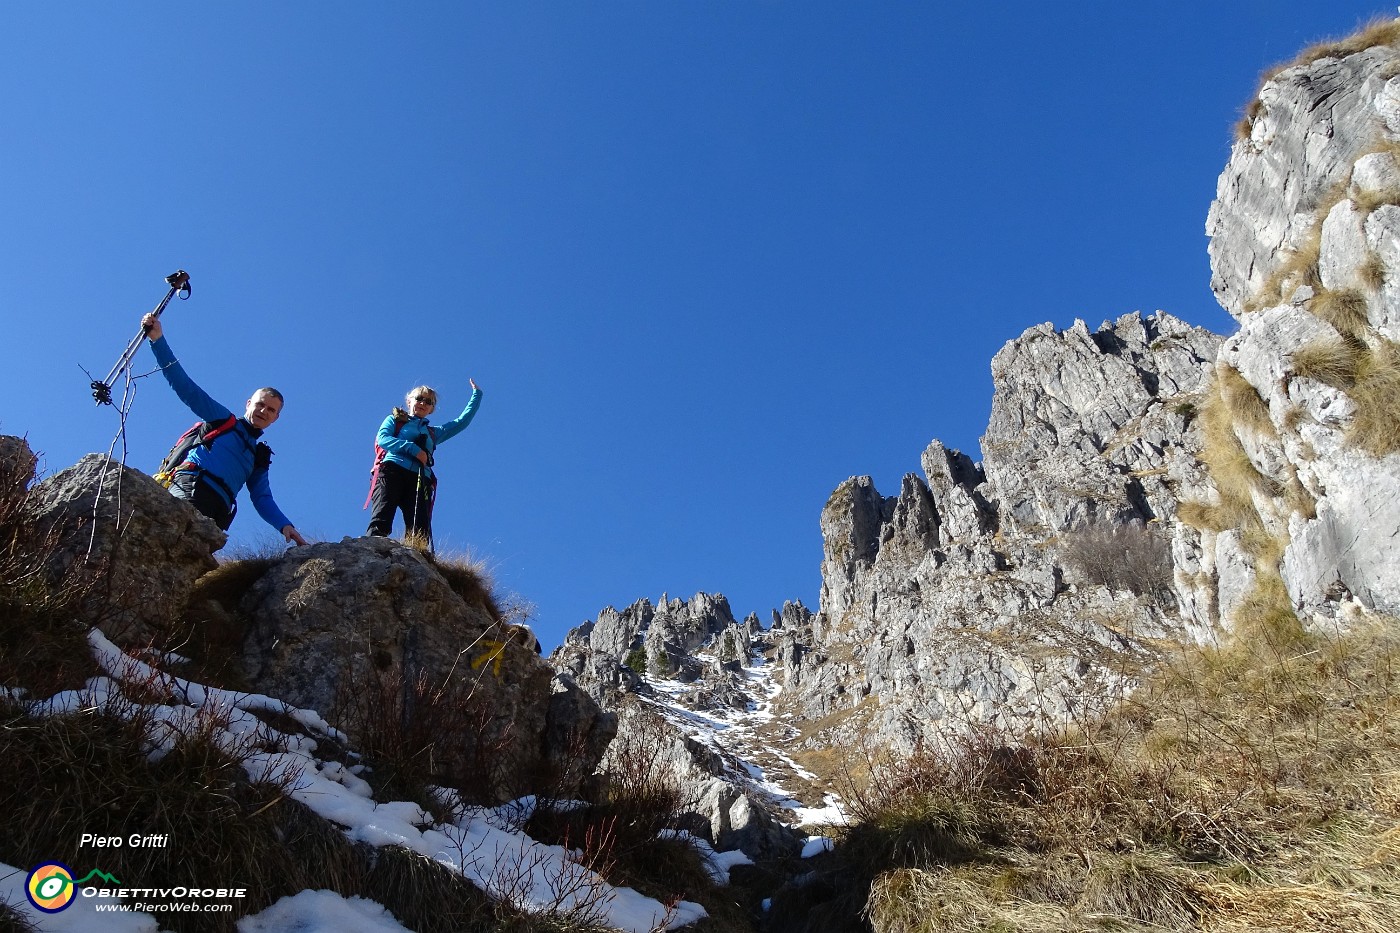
[1063,523,1175,605]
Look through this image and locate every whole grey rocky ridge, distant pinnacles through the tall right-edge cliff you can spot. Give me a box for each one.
[556,25,1400,818]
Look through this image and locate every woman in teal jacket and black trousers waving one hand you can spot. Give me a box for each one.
[365,380,482,544]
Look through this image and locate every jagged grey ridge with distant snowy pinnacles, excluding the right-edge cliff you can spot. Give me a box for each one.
[552,314,1221,821]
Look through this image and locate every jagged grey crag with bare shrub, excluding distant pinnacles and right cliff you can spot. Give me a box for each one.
[780,314,1219,749]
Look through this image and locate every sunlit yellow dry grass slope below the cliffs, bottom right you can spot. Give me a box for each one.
[837,613,1400,933]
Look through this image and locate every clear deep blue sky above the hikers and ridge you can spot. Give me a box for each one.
[0,0,1394,647]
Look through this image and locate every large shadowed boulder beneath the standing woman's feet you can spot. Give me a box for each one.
[239,538,615,801]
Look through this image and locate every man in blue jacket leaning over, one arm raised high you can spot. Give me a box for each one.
[141,314,307,545]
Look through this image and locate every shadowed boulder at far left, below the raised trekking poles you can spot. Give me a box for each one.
[25,454,227,644]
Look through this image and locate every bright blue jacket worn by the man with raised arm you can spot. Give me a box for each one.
[151,336,293,531]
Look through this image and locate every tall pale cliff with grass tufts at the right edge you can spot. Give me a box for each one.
[1205,31,1400,616]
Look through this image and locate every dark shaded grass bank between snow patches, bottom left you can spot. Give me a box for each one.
[0,700,360,930]
